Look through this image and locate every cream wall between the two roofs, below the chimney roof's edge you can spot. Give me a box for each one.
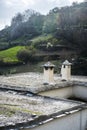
[39,83,87,101]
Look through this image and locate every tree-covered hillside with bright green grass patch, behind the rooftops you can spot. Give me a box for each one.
[0,2,87,75]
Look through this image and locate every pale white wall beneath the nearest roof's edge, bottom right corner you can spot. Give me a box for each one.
[27,109,87,130]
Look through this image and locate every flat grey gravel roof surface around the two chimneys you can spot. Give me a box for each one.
[0,72,87,93]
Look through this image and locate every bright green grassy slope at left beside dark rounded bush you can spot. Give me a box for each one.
[0,46,24,62]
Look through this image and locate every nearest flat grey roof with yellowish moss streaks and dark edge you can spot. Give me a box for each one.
[0,91,87,129]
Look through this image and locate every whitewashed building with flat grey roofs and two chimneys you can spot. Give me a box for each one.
[0,62,87,130]
